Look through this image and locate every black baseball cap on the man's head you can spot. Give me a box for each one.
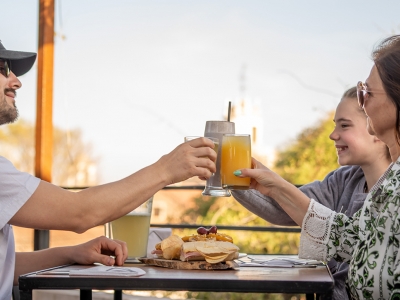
[0,41,36,77]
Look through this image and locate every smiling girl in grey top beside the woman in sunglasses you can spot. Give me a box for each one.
[232,87,391,300]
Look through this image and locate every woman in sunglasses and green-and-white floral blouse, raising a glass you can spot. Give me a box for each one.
[235,35,400,299]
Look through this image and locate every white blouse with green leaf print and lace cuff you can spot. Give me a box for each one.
[299,158,400,300]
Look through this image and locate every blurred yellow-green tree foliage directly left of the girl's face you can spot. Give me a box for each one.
[272,112,339,184]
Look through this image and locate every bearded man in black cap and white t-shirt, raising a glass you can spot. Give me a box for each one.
[0,42,216,299]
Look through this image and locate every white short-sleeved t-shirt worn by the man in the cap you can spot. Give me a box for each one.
[0,156,40,299]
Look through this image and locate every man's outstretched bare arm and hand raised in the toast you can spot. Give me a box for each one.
[9,138,216,233]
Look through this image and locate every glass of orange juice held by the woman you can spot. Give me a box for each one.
[221,134,251,190]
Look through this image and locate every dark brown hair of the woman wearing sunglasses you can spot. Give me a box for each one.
[372,35,400,145]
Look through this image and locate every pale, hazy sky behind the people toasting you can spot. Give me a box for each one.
[0,0,400,183]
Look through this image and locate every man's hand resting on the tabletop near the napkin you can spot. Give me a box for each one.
[70,236,128,266]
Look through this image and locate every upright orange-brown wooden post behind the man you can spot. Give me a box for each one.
[34,0,54,250]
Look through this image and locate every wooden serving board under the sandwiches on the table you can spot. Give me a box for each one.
[139,257,239,270]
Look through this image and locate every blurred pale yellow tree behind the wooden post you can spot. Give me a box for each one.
[0,120,98,186]
